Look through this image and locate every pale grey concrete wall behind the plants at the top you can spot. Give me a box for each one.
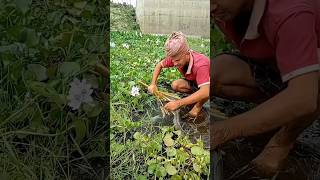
[136,0,210,38]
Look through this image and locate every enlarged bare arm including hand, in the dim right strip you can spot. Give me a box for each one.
[210,72,319,148]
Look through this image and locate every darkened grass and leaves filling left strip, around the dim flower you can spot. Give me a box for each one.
[0,0,109,179]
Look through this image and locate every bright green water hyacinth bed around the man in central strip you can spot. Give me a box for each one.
[110,29,210,179]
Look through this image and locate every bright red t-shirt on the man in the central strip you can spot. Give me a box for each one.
[161,51,210,88]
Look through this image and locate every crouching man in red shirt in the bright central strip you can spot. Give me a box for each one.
[148,32,210,117]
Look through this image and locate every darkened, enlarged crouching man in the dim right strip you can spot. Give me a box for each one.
[210,0,320,175]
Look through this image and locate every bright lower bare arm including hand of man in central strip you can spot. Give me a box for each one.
[164,84,210,111]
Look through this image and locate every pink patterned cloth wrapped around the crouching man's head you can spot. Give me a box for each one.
[164,31,190,57]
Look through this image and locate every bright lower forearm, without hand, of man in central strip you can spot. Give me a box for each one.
[178,84,210,106]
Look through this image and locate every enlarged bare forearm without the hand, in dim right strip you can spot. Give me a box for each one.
[224,71,318,138]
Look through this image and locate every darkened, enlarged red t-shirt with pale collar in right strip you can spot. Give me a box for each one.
[216,0,320,82]
